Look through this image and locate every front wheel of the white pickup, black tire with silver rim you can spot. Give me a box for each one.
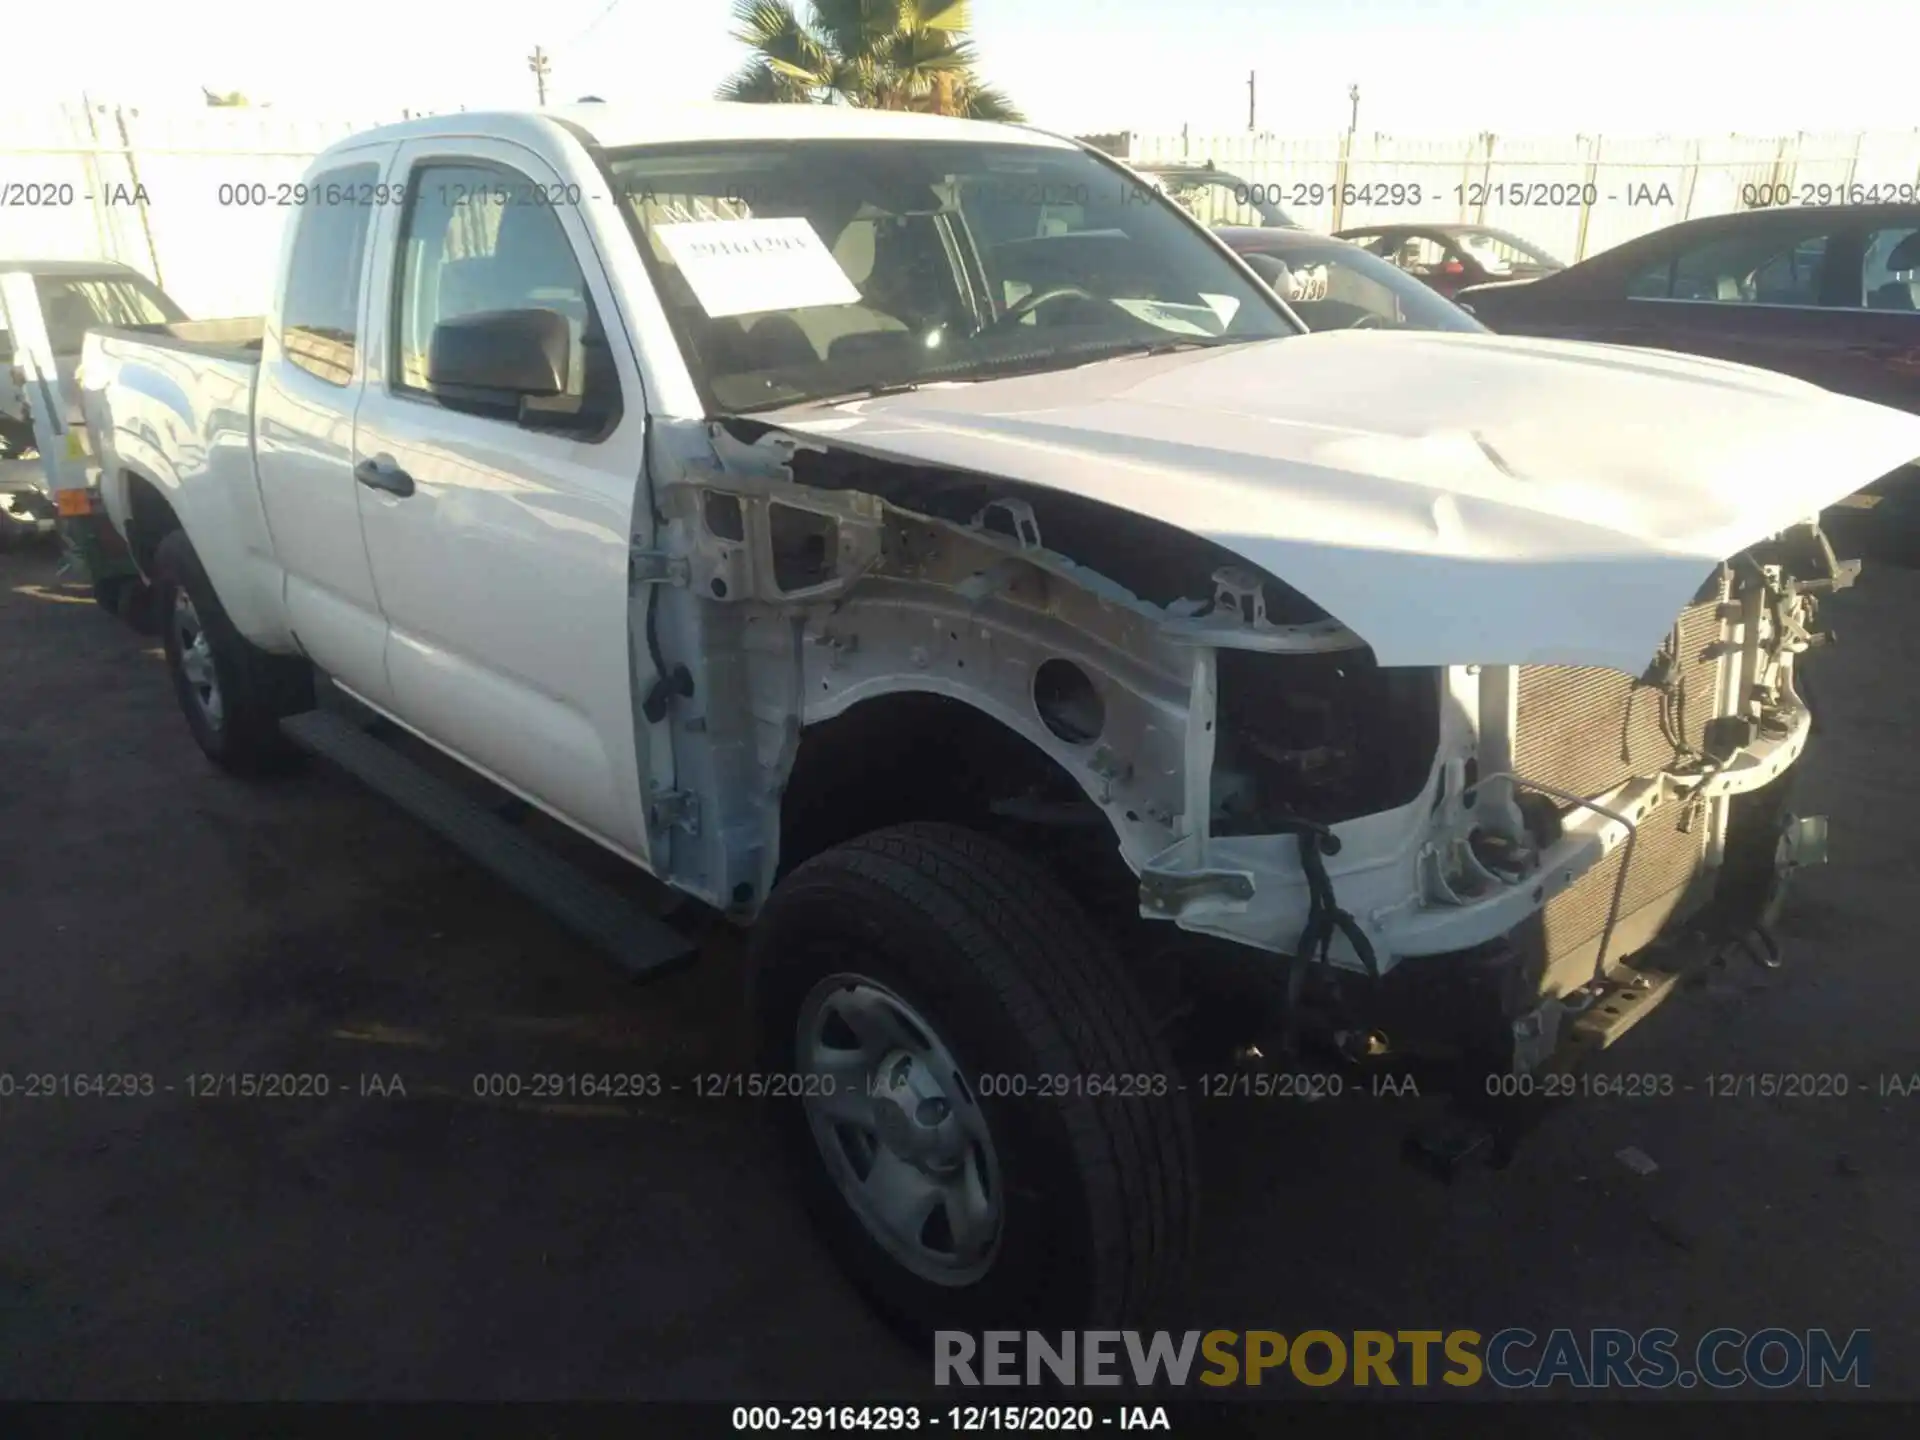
[753,824,1194,1336]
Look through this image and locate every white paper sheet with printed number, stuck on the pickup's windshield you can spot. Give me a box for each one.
[653,215,860,319]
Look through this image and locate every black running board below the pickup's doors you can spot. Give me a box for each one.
[280,710,695,977]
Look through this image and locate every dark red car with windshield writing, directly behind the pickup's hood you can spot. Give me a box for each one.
[1217,225,1486,330]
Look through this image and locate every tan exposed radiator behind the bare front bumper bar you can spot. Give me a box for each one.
[1513,570,1728,964]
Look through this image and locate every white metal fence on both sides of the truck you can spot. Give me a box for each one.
[11,106,1920,317]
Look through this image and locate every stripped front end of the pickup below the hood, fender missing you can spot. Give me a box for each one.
[636,385,1857,1175]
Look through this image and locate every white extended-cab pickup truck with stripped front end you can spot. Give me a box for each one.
[84,106,1920,1329]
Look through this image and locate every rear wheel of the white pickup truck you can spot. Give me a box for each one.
[152,530,313,776]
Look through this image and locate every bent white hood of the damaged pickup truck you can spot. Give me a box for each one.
[756,330,1920,674]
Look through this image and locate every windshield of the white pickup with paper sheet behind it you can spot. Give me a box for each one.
[609,140,1296,413]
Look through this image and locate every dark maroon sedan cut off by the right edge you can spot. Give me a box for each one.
[1455,205,1920,563]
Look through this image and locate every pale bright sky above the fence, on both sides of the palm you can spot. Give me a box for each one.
[0,0,1920,144]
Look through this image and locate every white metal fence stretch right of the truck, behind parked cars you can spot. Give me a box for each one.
[1098,129,1920,261]
